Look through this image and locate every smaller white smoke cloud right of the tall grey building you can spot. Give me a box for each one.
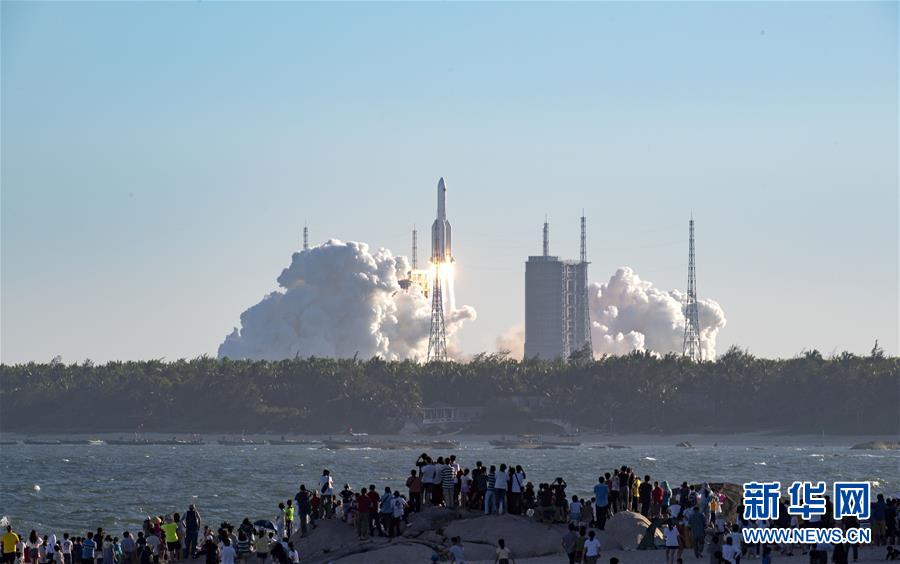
[589,266,726,359]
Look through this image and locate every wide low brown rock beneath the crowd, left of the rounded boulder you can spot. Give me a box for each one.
[444,515,566,560]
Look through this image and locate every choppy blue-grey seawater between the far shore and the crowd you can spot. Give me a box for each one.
[0,437,900,535]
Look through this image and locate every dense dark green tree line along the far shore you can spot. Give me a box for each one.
[0,346,900,434]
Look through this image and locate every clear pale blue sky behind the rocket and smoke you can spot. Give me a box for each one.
[0,2,900,363]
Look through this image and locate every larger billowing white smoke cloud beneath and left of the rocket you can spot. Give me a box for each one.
[219,239,475,360]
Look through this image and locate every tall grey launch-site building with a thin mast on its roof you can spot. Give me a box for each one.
[525,218,591,359]
